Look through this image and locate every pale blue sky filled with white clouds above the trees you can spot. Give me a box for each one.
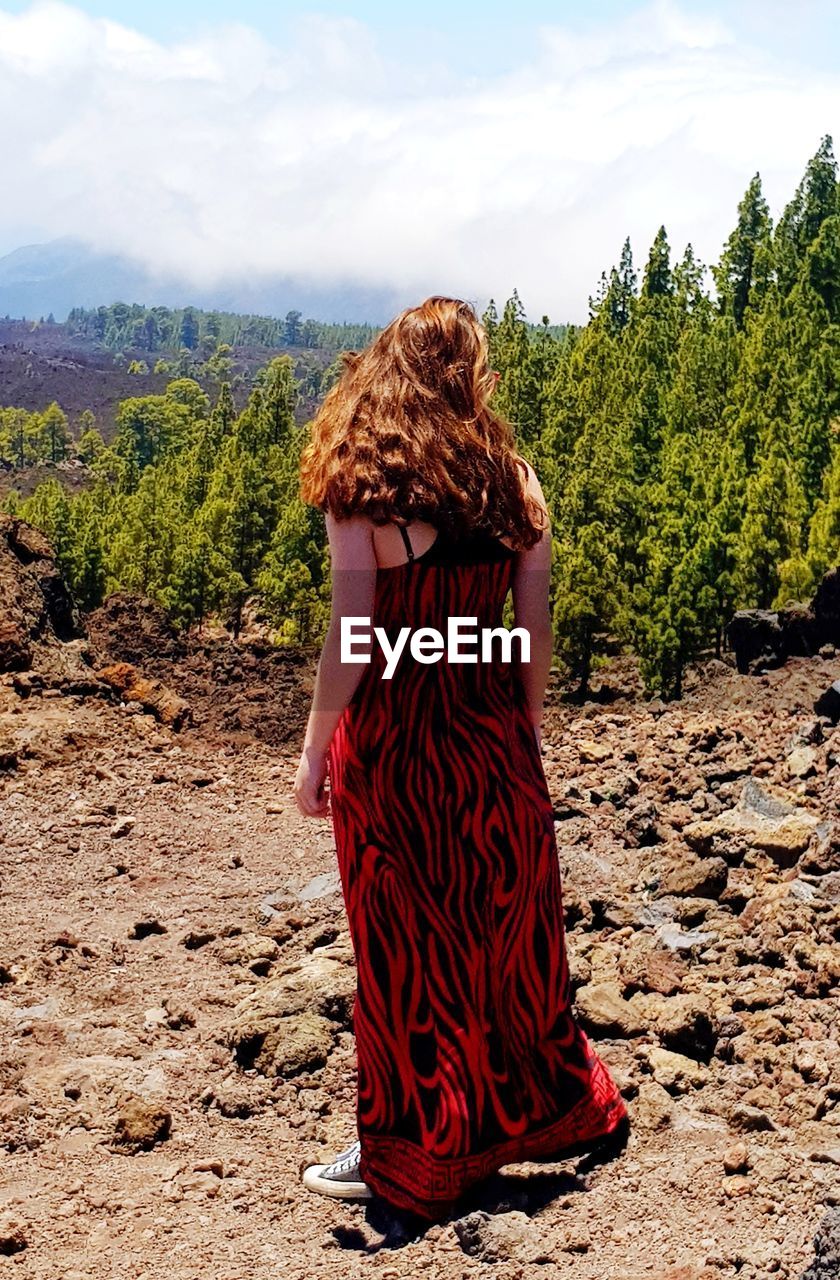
[0,0,840,321]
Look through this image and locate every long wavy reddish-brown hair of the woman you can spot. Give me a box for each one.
[301,296,544,548]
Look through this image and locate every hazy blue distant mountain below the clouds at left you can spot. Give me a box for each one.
[0,237,404,324]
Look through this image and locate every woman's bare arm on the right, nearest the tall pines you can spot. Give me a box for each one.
[513,466,553,742]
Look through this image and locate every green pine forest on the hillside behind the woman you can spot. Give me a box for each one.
[0,137,840,699]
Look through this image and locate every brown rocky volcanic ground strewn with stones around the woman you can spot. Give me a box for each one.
[0,514,840,1280]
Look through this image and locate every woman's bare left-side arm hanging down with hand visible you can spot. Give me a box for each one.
[295,515,376,818]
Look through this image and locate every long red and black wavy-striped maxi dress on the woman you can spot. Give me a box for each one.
[329,522,626,1219]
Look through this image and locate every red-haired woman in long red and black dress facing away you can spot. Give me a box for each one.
[295,297,627,1219]
